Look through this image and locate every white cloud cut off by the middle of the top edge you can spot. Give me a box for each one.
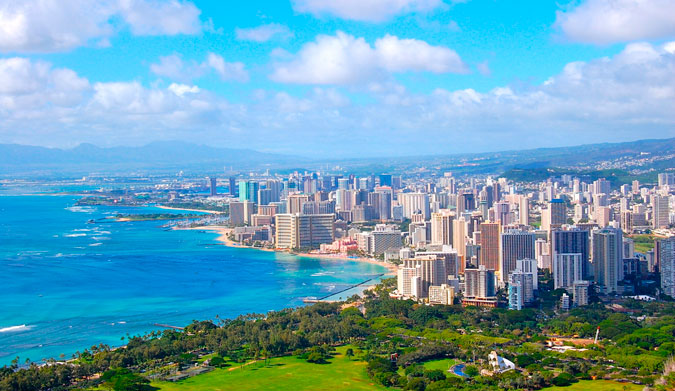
[293,0,444,22]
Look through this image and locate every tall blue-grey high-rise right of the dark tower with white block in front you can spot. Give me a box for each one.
[593,228,623,293]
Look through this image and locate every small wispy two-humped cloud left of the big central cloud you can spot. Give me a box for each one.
[150,53,249,83]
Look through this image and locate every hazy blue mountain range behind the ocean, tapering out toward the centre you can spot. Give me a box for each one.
[0,141,299,174]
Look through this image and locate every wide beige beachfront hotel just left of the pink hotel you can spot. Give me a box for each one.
[275,213,335,248]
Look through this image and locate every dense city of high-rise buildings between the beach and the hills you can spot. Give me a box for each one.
[210,172,675,309]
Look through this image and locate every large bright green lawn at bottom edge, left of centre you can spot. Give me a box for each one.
[152,347,386,391]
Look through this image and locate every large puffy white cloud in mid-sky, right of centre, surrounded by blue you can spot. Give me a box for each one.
[271,31,468,84]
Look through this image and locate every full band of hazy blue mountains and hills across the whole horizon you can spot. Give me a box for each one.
[0,138,675,175]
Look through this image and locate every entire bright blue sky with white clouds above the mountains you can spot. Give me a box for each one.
[0,0,675,157]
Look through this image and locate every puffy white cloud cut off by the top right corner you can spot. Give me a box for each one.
[555,0,675,45]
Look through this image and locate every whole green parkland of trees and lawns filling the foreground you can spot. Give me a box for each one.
[0,279,675,391]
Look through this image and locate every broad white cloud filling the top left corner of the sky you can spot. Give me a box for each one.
[0,0,202,52]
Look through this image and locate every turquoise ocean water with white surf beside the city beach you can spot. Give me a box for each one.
[0,195,385,365]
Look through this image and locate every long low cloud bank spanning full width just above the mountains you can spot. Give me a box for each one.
[0,43,675,157]
